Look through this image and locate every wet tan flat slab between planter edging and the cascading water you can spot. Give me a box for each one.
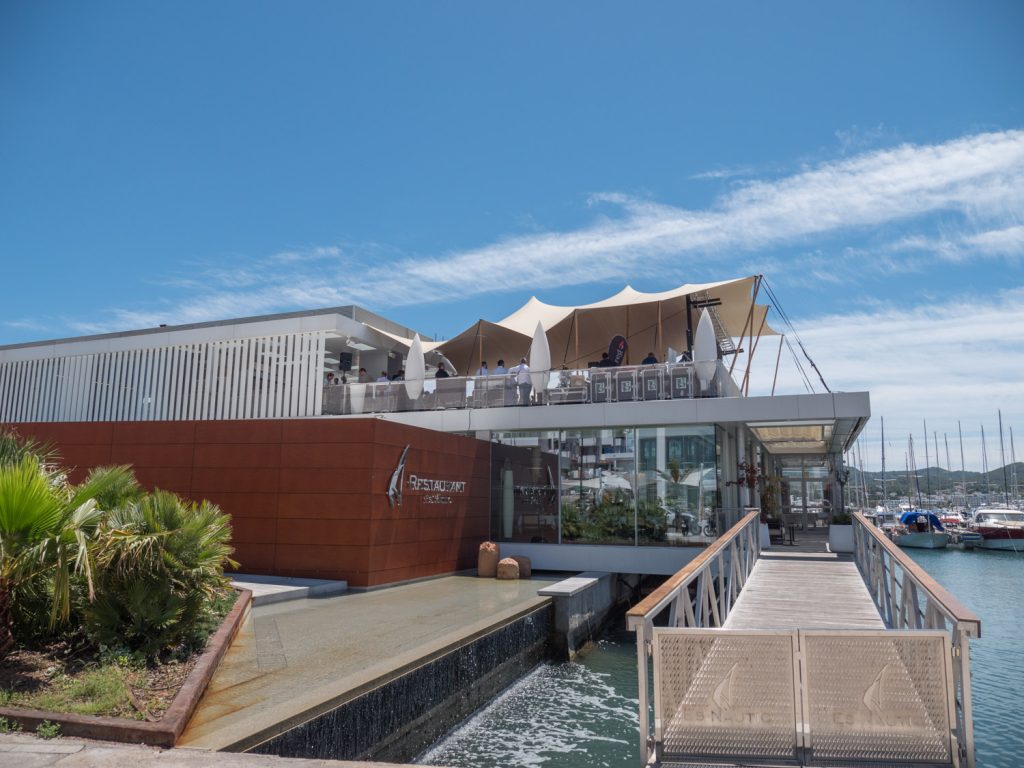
[179,575,557,750]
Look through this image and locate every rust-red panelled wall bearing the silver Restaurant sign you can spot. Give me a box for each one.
[4,419,489,587]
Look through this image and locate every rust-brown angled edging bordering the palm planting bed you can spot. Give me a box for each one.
[0,590,253,748]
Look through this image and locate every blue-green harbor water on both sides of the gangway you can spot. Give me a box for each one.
[417,549,1024,768]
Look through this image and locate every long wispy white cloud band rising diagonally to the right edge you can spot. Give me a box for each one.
[61,131,1024,330]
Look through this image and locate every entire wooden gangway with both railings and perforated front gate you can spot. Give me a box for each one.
[628,511,980,767]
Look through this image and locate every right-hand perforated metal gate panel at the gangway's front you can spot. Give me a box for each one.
[801,632,952,764]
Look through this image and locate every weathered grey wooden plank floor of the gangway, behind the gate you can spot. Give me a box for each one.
[725,557,885,630]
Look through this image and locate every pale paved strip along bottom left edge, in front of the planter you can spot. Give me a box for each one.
[0,734,428,768]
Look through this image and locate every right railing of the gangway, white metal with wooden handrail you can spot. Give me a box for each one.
[853,512,981,768]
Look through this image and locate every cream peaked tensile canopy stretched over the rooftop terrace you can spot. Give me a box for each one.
[432,276,776,374]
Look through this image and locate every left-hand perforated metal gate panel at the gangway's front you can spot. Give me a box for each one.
[654,629,799,760]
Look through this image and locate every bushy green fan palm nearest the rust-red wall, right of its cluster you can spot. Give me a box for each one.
[82,490,234,658]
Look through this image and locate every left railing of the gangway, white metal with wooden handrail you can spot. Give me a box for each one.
[626,509,761,764]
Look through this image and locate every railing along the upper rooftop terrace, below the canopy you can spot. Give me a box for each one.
[323,361,741,416]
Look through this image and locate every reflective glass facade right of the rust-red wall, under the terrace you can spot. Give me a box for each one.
[490,425,722,547]
